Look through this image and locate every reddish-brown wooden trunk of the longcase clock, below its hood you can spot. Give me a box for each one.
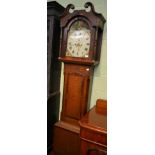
[61,64,93,124]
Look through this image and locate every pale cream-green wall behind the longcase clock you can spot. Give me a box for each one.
[48,0,107,111]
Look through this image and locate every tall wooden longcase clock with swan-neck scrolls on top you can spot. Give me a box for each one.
[53,2,105,155]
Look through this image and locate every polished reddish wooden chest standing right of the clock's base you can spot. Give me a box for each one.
[80,99,107,155]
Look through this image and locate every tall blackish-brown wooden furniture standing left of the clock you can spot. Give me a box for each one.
[47,1,64,150]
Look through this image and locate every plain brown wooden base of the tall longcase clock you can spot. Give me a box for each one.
[53,121,80,155]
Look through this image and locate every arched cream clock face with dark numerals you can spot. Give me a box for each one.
[66,21,91,58]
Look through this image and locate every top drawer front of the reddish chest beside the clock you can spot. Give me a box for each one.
[80,128,107,145]
